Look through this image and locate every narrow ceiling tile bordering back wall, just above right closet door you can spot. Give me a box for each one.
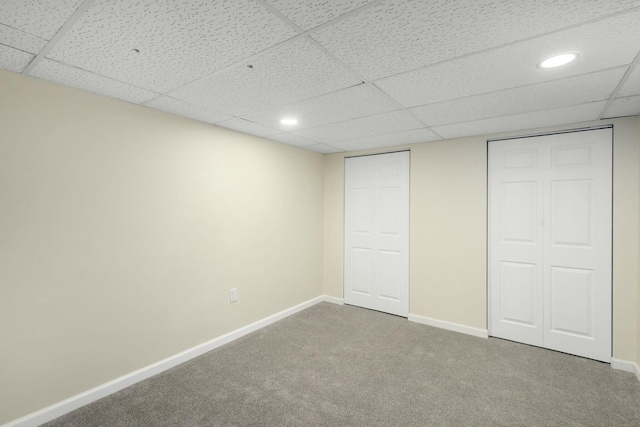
[432,101,606,139]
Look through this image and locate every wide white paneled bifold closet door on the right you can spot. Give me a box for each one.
[488,128,612,362]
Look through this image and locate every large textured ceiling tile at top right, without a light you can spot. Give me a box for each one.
[313,0,640,79]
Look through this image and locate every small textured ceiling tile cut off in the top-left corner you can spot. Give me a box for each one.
[0,0,83,40]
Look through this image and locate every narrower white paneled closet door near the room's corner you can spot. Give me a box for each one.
[344,151,410,317]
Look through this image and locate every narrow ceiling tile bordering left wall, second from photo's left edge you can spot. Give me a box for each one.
[30,59,158,104]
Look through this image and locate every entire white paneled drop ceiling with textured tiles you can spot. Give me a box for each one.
[0,0,640,153]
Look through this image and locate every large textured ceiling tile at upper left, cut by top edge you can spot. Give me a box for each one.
[49,0,297,92]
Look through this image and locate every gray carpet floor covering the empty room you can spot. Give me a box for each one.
[45,303,640,427]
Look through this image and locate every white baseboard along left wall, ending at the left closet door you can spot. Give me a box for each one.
[2,295,324,427]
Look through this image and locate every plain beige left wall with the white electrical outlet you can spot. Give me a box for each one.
[0,71,324,424]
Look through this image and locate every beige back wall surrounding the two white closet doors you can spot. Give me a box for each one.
[324,118,640,361]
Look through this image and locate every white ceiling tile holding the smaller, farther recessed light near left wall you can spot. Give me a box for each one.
[246,84,398,131]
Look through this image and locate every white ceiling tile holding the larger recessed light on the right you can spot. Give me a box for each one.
[375,11,640,107]
